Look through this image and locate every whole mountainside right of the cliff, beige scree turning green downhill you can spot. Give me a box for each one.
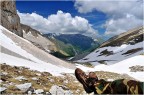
[21,24,75,59]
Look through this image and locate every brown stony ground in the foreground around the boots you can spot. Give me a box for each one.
[0,63,133,95]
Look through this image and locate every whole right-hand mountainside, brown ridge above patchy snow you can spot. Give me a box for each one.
[77,27,144,65]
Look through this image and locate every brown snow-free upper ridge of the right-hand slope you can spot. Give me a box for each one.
[100,26,144,47]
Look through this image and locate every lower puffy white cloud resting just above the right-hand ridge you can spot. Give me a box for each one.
[105,15,143,36]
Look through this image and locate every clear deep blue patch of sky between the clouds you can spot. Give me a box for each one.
[16,1,107,34]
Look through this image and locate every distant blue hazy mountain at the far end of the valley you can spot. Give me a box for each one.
[55,34,99,51]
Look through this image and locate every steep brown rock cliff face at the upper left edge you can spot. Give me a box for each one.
[0,0,23,37]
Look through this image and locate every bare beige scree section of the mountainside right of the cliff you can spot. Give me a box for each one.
[21,24,58,53]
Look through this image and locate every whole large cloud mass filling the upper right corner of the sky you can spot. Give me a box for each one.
[75,0,143,35]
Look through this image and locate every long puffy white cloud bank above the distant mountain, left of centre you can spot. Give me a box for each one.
[18,11,98,37]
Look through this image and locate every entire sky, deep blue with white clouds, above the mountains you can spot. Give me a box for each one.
[16,0,143,38]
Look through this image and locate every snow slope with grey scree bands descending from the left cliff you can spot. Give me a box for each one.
[0,26,75,75]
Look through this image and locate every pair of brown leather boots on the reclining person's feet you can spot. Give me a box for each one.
[75,68,98,93]
